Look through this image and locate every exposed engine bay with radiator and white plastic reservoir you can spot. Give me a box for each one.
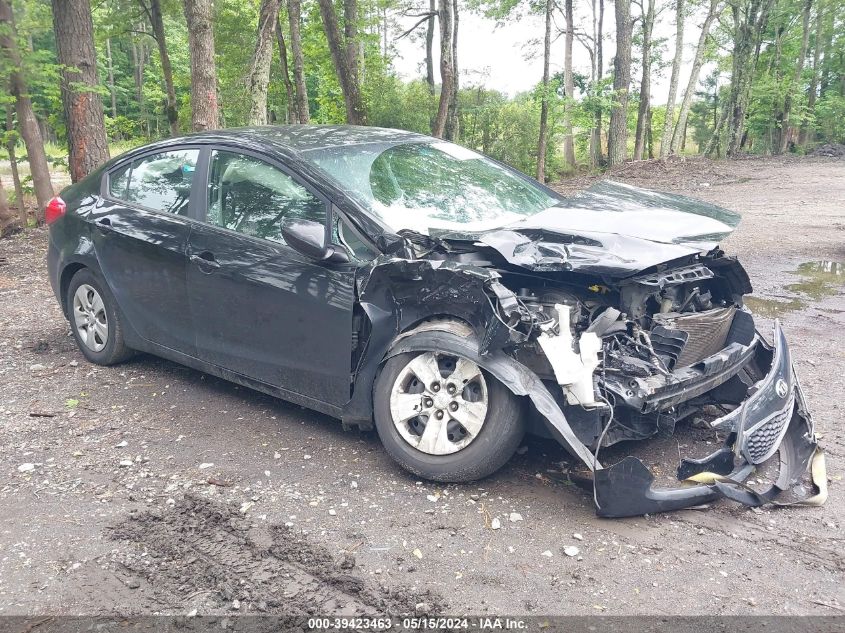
[498,252,755,448]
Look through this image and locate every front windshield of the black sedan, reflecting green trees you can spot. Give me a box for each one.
[304,141,560,235]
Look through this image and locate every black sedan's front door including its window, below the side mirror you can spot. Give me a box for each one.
[188,148,355,406]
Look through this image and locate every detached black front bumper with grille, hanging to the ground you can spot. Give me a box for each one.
[593,321,823,517]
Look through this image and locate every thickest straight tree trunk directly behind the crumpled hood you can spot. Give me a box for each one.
[607,0,632,167]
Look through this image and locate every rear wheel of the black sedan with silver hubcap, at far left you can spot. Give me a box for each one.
[65,268,134,365]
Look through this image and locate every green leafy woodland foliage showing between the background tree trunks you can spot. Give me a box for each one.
[6,0,845,193]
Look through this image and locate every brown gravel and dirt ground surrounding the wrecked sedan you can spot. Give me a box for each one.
[0,158,845,616]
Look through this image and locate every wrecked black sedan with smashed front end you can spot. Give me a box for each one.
[46,126,824,516]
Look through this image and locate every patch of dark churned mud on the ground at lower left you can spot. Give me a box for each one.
[108,495,441,623]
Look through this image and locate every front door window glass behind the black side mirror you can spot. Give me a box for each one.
[206,150,326,244]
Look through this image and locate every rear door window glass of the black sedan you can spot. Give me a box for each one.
[109,149,199,215]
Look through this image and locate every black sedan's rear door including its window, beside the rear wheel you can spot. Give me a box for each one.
[90,147,201,355]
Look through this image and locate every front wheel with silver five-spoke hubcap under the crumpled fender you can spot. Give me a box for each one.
[373,352,525,482]
